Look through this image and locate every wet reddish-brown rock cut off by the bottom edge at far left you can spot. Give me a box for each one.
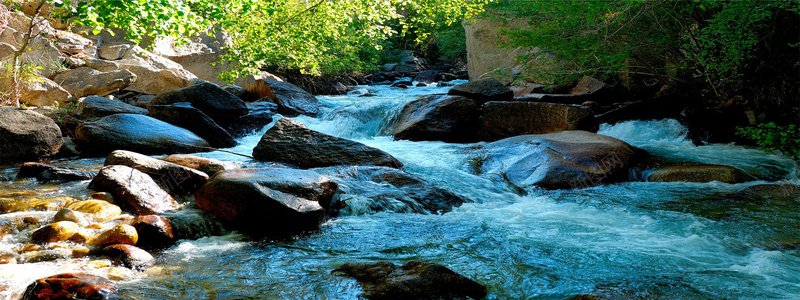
[22,273,119,300]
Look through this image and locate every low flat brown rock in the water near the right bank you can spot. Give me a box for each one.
[646,164,753,183]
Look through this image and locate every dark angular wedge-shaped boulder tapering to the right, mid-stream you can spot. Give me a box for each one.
[253,118,403,168]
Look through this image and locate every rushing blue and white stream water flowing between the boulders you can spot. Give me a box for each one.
[0,83,800,299]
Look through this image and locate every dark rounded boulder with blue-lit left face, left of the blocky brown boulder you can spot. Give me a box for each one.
[392,95,480,142]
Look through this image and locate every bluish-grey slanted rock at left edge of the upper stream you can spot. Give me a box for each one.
[264,79,319,117]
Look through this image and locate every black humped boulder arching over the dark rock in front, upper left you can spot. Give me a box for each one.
[150,82,248,126]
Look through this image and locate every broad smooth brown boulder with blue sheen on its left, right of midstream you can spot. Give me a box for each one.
[474,131,647,189]
